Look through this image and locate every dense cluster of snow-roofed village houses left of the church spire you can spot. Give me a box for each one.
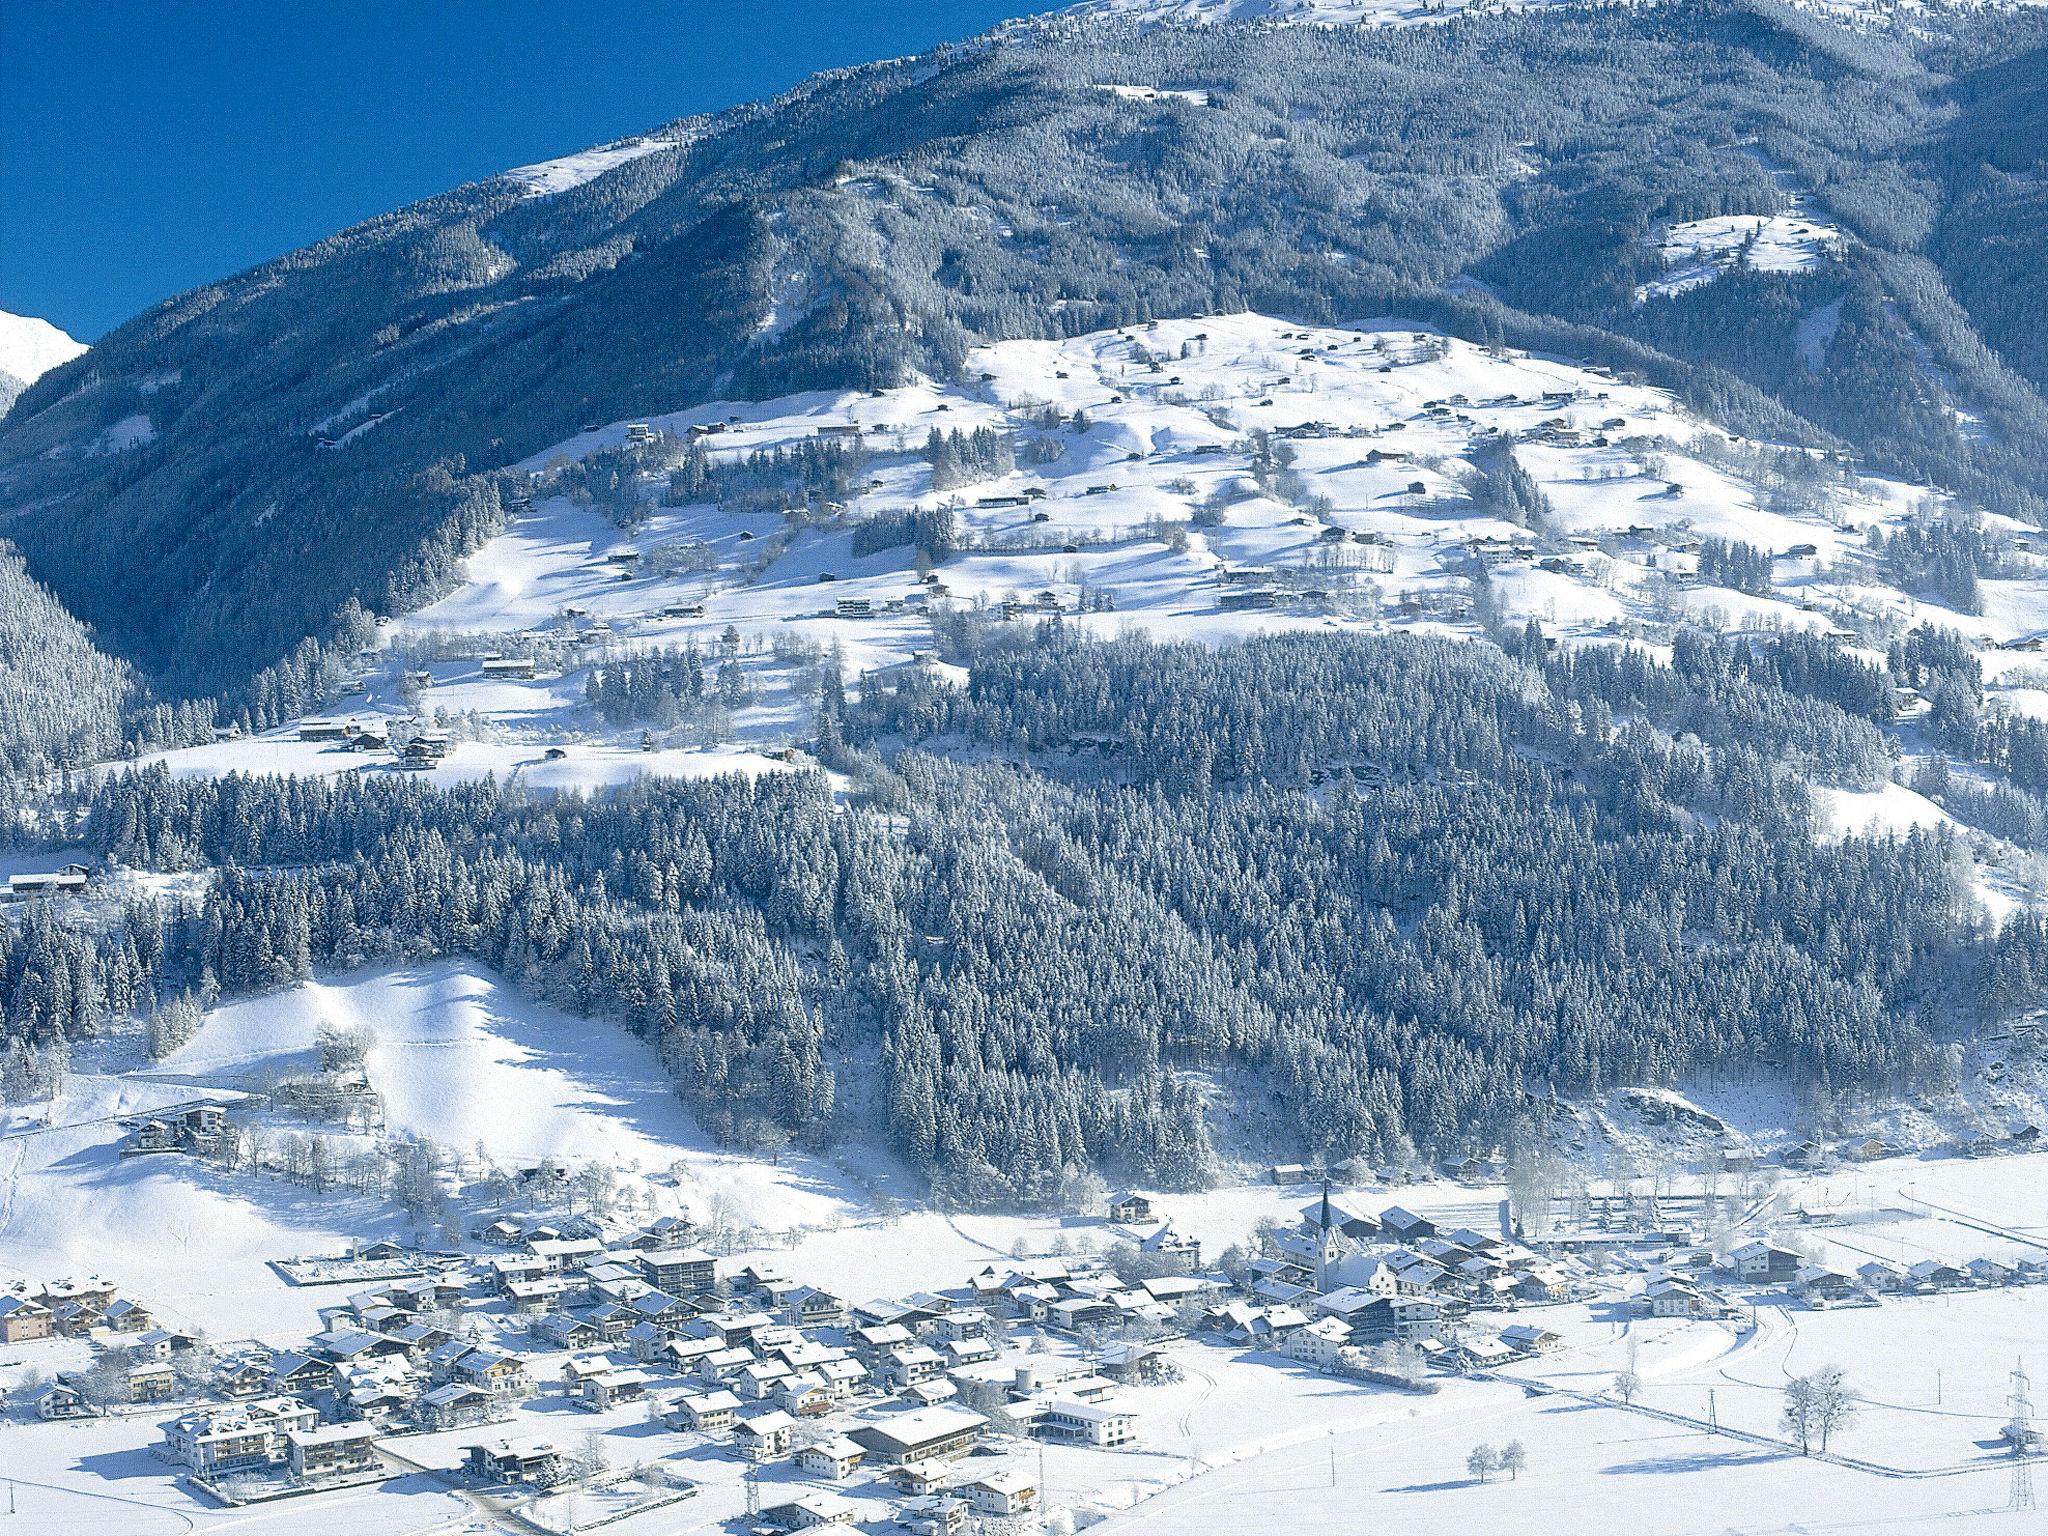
[112,1206,1171,1532]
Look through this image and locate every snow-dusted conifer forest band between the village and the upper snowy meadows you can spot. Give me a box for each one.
[0,633,2048,1202]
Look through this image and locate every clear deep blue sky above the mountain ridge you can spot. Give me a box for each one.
[12,0,1055,340]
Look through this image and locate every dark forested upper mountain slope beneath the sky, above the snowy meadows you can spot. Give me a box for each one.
[0,0,2048,694]
